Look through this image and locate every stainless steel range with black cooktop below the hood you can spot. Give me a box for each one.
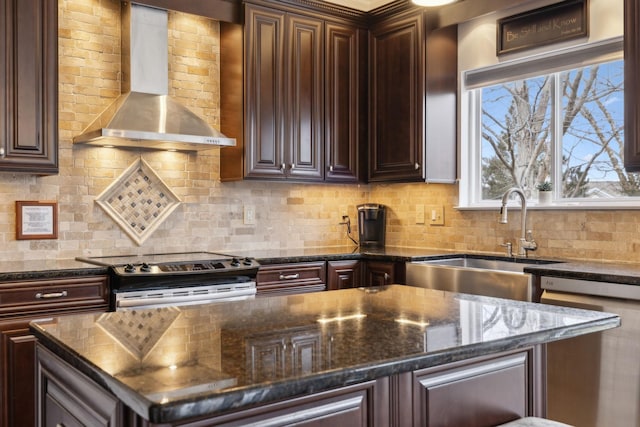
[76,252,259,311]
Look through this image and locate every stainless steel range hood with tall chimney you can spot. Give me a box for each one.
[73,2,236,151]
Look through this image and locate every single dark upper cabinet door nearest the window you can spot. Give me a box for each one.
[369,14,424,181]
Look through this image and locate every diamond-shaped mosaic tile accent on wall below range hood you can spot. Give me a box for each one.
[96,158,181,245]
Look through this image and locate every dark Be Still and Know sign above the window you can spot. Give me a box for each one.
[496,0,589,55]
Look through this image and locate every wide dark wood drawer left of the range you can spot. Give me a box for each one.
[0,276,109,316]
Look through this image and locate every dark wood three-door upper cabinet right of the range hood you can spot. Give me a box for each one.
[226,2,367,182]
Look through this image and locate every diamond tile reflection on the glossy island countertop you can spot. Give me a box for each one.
[96,307,180,360]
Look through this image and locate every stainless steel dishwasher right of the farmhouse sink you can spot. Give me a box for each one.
[541,276,640,427]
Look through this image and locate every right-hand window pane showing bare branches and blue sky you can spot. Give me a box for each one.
[560,61,640,198]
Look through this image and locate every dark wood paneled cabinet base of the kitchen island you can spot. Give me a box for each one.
[36,344,544,427]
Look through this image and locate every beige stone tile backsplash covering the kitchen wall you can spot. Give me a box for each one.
[0,0,640,262]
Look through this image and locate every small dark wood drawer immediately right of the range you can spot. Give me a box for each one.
[257,261,327,294]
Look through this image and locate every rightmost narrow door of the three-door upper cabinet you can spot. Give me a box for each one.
[325,23,367,182]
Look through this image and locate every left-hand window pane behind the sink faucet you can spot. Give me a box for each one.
[481,76,553,200]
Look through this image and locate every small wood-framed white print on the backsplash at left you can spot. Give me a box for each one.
[16,201,58,240]
